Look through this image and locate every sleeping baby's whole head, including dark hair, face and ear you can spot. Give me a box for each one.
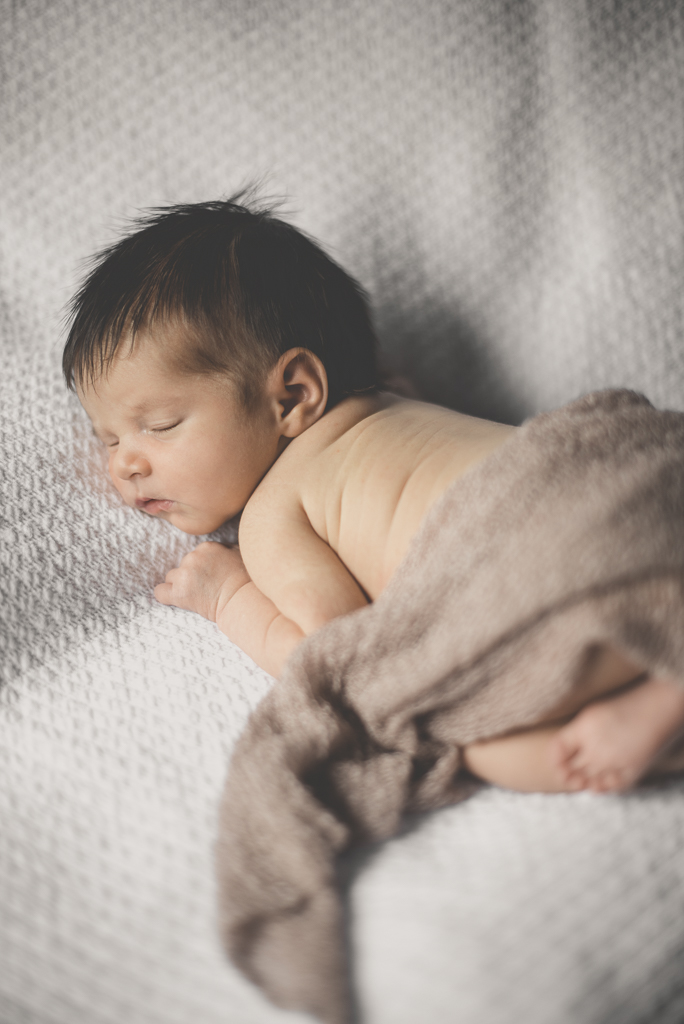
[62,197,378,534]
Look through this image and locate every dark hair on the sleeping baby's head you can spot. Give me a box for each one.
[62,191,379,408]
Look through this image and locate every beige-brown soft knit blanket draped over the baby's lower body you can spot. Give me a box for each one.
[217,391,684,1024]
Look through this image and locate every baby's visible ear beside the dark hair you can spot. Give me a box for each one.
[269,348,328,437]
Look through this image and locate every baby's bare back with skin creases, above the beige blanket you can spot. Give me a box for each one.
[241,394,515,599]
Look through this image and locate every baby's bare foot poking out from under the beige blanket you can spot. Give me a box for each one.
[553,678,684,793]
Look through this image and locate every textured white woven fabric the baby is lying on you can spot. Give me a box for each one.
[0,0,684,1024]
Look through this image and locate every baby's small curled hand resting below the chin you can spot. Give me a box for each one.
[155,541,250,623]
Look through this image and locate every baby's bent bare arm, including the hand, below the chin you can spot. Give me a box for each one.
[155,517,367,676]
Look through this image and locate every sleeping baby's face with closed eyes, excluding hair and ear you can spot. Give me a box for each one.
[79,336,283,535]
